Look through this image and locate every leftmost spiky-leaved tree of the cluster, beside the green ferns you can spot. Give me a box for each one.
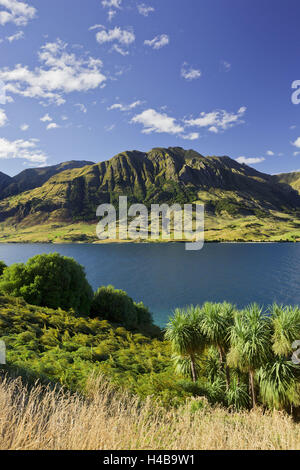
[165,306,205,382]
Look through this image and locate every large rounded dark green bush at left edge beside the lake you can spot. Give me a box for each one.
[0,253,93,315]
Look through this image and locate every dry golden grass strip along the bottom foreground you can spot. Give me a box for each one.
[0,379,300,450]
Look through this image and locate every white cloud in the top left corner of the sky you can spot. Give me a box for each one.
[0,0,36,26]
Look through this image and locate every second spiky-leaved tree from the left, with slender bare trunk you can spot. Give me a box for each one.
[200,302,235,389]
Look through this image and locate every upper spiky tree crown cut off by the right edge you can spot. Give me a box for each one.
[270,304,300,357]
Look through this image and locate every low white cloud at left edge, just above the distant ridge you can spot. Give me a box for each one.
[0,138,47,163]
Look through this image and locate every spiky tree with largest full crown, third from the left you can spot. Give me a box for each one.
[228,304,272,407]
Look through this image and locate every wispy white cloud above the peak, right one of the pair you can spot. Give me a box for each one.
[185,106,247,133]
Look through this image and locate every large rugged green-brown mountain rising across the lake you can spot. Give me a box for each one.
[0,147,300,240]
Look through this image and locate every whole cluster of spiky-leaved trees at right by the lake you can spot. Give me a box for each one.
[166,302,300,410]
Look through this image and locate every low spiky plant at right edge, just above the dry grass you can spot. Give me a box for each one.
[257,358,300,409]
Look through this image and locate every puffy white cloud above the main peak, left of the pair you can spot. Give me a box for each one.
[131,109,184,134]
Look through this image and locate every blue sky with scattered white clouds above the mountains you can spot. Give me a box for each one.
[0,0,300,175]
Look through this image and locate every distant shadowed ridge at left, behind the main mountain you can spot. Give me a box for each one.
[0,160,93,199]
